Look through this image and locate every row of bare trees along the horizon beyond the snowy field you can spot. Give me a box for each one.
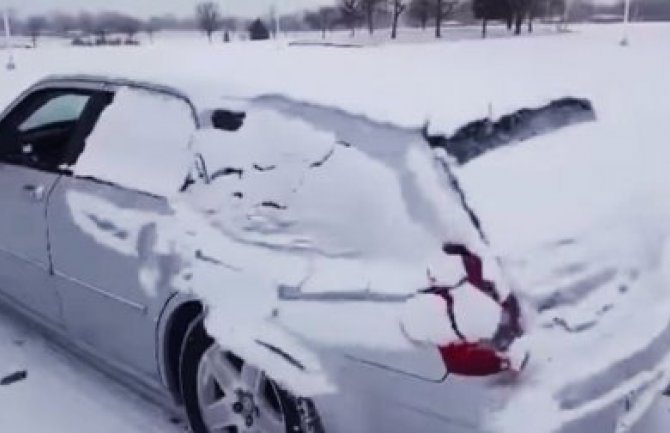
[6,0,670,45]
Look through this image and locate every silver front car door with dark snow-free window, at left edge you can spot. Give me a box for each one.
[0,89,106,323]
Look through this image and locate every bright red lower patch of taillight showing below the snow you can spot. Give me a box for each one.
[440,341,510,377]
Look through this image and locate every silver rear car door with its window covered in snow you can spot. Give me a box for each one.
[48,83,195,378]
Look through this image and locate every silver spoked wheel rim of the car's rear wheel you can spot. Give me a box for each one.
[197,344,286,433]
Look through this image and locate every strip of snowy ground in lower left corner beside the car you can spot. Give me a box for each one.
[0,309,183,433]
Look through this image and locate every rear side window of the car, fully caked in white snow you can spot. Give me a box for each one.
[73,87,196,196]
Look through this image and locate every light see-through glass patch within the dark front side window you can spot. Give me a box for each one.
[19,94,91,131]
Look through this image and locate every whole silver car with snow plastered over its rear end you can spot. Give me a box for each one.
[0,76,664,433]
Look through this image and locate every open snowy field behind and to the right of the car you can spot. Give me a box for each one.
[0,25,670,432]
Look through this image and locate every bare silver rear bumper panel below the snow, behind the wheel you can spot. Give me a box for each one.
[316,344,500,433]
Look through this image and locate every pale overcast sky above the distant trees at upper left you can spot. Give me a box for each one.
[5,0,335,17]
